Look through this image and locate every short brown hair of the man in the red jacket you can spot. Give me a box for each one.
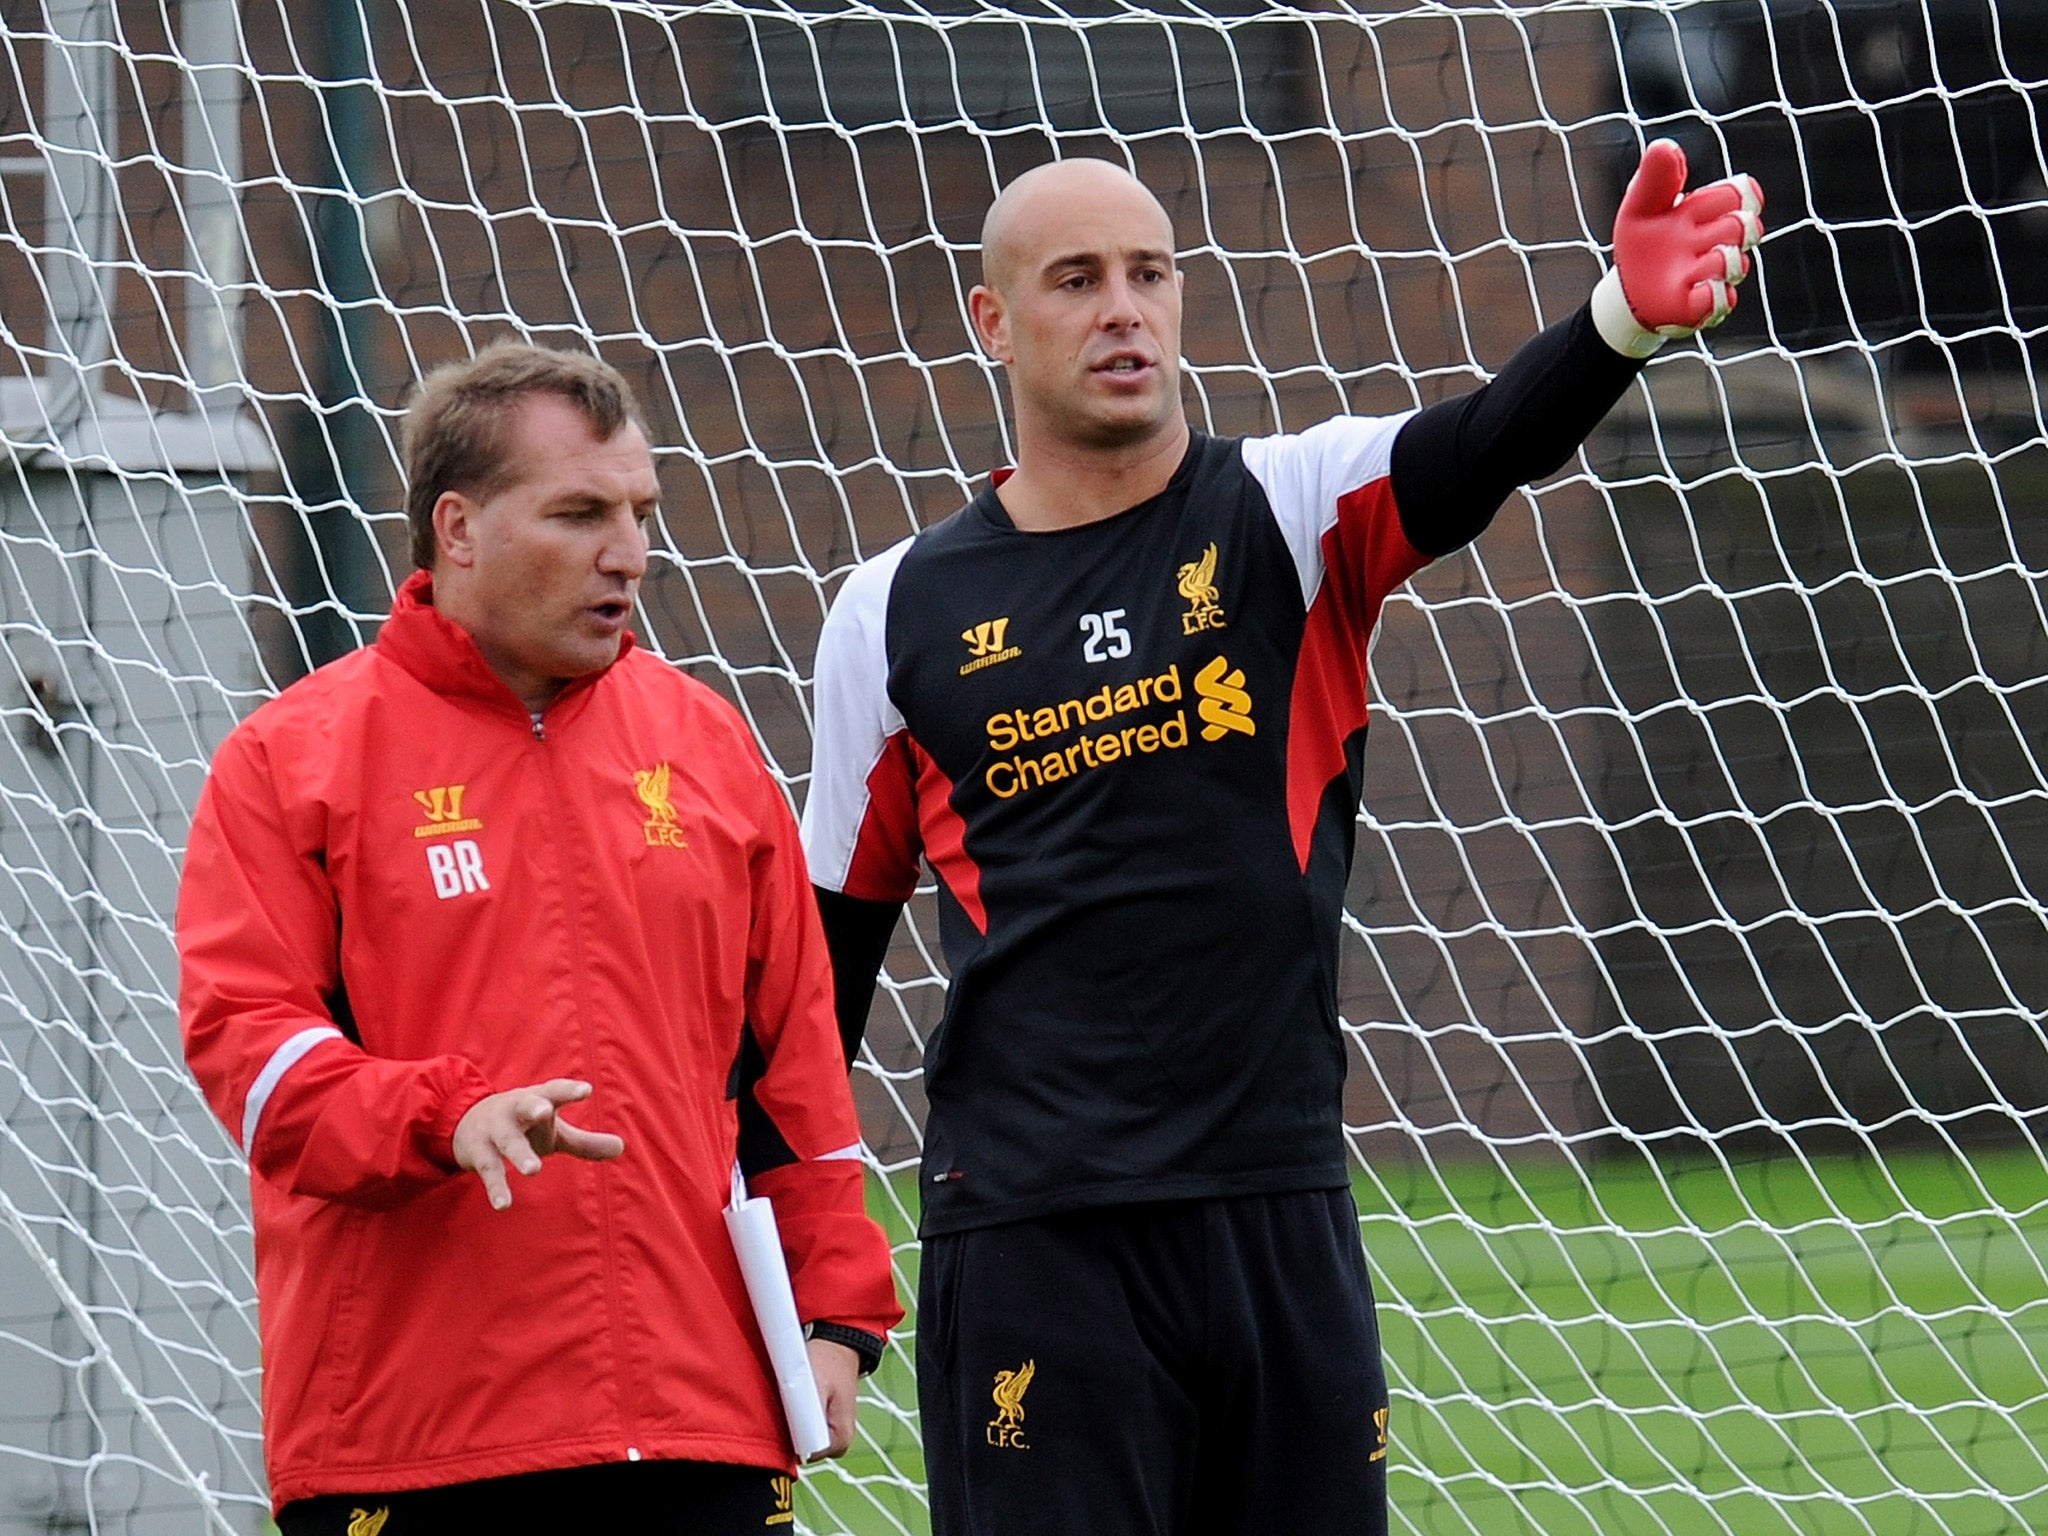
[401,340,647,571]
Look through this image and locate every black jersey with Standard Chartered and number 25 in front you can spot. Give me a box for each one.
[805,303,1634,1233]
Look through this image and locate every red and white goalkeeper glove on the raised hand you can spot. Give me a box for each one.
[1593,139,1763,356]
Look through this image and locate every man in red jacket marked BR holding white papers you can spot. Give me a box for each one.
[178,344,901,1536]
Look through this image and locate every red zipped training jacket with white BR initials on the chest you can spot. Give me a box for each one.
[178,573,903,1505]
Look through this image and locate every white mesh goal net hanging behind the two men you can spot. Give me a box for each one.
[0,0,2048,1536]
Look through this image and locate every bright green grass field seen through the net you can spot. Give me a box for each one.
[801,1149,2048,1536]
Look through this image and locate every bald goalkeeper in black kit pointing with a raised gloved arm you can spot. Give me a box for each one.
[805,143,1761,1536]
